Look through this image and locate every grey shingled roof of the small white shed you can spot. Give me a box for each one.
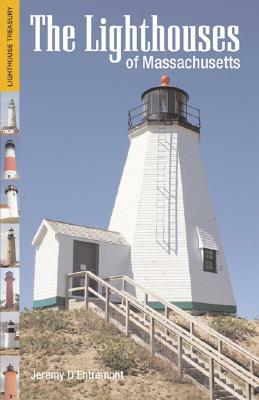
[34,219,129,246]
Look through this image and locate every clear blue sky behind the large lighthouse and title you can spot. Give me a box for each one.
[19,0,259,318]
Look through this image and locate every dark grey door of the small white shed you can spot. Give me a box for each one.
[73,240,99,296]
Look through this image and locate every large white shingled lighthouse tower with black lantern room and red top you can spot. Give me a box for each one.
[109,76,236,313]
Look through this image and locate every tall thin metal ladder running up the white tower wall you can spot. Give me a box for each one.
[156,125,178,254]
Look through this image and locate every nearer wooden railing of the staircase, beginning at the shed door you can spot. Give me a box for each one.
[66,271,259,399]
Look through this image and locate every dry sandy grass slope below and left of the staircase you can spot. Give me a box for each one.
[20,310,207,400]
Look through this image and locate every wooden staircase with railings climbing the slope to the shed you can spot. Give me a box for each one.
[66,271,259,400]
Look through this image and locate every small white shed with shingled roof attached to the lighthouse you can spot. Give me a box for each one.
[33,219,130,308]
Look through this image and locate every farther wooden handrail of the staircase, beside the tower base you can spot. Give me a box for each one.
[106,275,259,364]
